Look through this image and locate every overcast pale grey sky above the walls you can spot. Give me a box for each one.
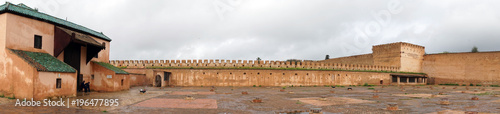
[3,0,500,60]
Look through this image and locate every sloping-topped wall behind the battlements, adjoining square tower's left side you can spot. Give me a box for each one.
[321,54,374,65]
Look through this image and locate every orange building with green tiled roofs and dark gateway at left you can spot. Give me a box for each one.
[0,2,129,99]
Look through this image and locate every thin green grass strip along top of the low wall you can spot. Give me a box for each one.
[146,66,426,75]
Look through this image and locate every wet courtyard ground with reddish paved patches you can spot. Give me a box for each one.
[0,85,500,114]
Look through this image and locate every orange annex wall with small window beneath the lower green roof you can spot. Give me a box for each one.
[33,72,77,100]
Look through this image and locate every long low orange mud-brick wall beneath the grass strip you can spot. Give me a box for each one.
[146,69,391,86]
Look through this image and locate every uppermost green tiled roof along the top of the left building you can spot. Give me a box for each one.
[0,2,111,41]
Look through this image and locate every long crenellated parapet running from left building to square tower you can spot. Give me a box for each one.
[109,59,399,71]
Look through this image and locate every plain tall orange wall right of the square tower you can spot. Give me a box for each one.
[422,52,500,84]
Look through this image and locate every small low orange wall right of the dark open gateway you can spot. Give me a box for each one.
[89,63,130,91]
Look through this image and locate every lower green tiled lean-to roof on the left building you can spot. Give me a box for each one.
[10,49,76,72]
